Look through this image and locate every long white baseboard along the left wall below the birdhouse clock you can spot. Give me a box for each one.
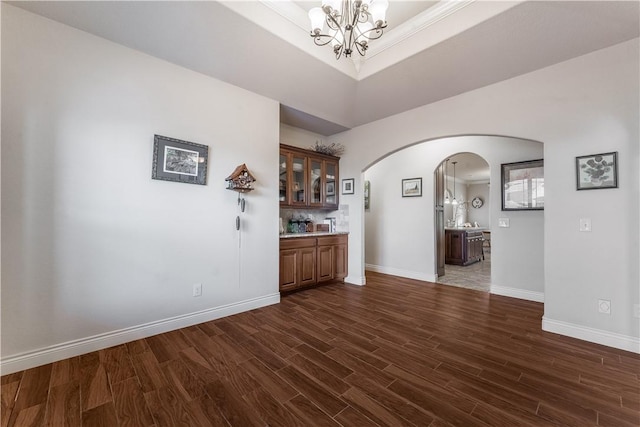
[0,293,280,375]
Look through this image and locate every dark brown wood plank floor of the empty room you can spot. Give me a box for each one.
[1,273,640,427]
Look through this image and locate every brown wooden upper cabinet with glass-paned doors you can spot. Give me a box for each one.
[280,145,340,209]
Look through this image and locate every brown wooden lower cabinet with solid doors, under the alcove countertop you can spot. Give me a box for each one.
[280,235,348,291]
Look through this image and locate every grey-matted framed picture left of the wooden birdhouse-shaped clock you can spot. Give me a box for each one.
[151,135,209,185]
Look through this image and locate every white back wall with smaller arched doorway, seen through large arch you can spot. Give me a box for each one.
[364,136,544,294]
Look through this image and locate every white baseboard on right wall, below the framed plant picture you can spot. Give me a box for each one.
[542,316,640,354]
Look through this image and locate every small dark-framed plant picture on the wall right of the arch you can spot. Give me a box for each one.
[576,151,618,190]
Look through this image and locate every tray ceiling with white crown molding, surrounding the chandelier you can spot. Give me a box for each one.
[8,0,640,135]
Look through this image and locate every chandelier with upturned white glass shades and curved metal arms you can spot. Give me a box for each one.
[309,0,389,59]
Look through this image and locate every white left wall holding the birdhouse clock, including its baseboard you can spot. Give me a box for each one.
[2,3,279,374]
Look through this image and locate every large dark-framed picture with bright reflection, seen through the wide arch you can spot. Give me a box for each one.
[502,159,544,211]
